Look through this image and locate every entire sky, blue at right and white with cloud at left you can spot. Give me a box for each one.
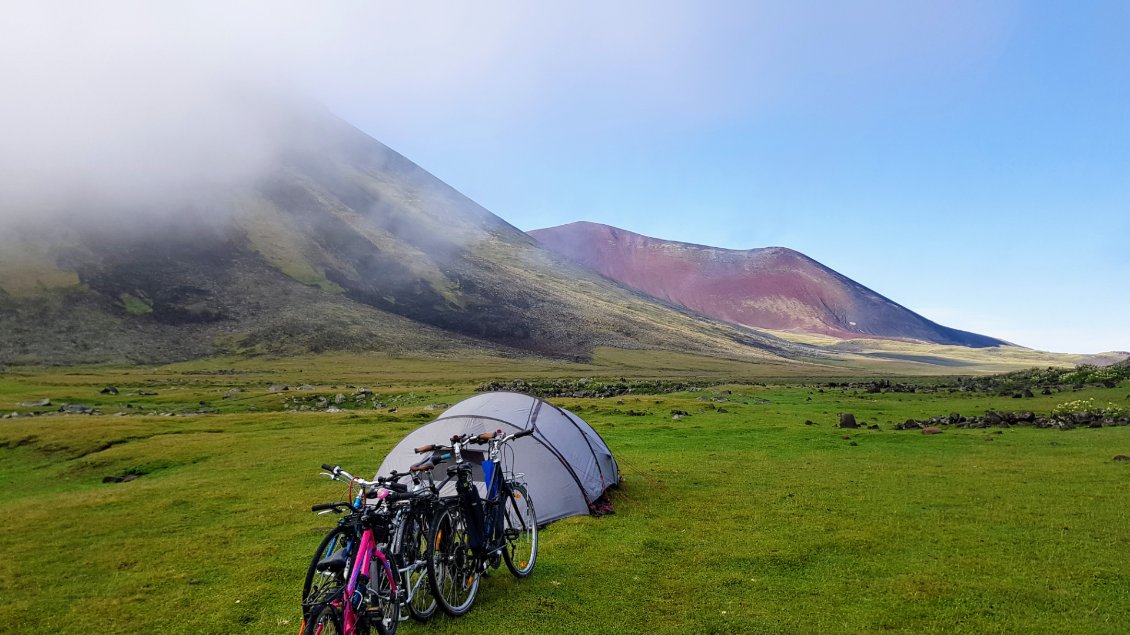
[0,0,1130,353]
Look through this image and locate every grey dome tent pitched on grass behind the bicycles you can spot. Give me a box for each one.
[379,392,620,524]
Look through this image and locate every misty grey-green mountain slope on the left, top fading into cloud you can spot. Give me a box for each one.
[0,106,803,364]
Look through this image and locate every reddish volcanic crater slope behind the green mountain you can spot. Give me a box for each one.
[529,223,1007,347]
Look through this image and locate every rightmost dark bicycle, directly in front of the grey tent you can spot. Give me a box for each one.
[416,429,538,616]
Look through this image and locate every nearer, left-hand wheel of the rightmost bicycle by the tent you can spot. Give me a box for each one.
[427,507,479,617]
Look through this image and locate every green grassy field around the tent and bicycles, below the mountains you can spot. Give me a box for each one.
[0,357,1130,634]
